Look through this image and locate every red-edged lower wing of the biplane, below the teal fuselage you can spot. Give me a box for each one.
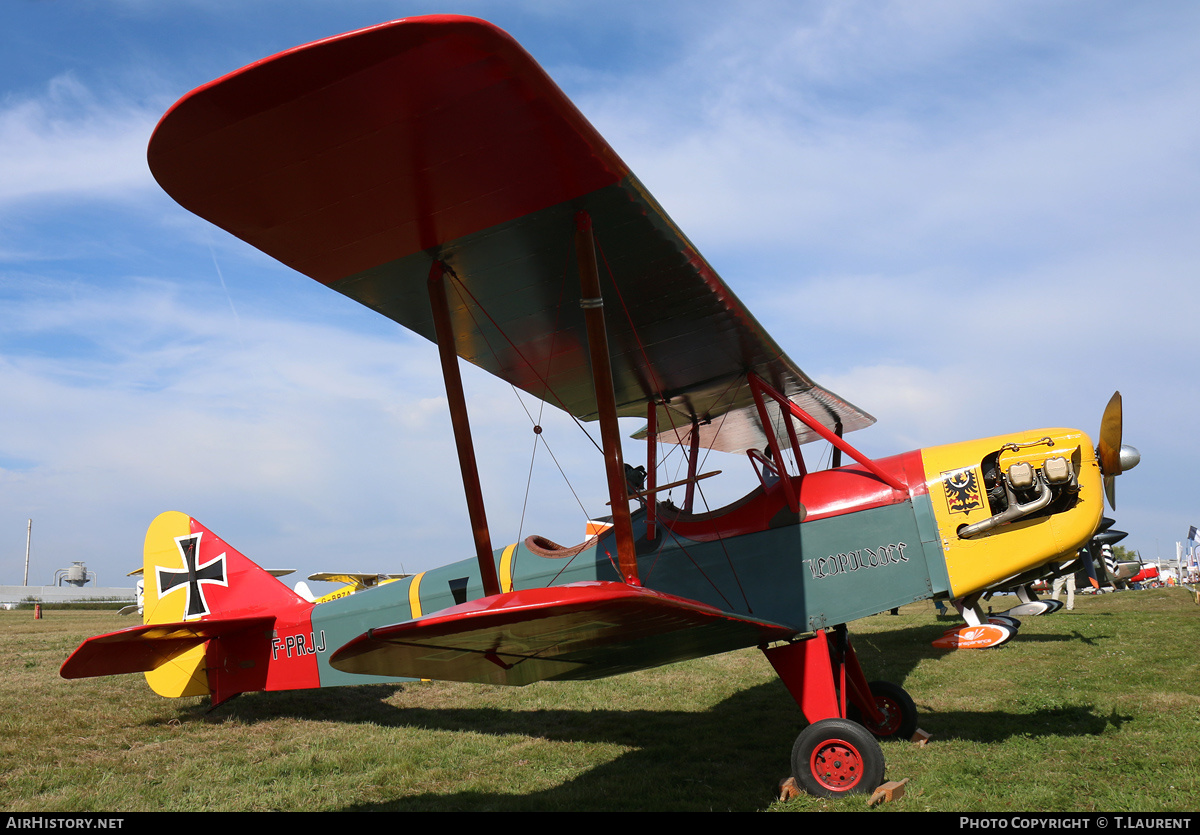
[330,582,796,685]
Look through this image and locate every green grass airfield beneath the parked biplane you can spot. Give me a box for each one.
[0,589,1200,812]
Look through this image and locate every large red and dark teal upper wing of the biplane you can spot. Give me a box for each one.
[149,16,874,451]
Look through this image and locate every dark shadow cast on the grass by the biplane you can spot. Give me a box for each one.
[154,657,1130,811]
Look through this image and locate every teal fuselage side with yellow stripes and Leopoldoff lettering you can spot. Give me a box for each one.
[312,474,949,686]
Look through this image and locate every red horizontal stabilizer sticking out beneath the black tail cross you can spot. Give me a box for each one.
[59,617,275,679]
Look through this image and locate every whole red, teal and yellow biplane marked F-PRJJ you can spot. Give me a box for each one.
[62,17,1137,795]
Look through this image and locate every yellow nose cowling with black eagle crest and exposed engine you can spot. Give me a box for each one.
[922,428,1104,597]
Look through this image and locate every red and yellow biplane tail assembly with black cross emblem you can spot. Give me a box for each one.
[61,511,318,703]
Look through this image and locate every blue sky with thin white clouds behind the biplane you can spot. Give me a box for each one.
[0,0,1200,584]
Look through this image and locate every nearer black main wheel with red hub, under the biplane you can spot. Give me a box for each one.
[792,719,883,798]
